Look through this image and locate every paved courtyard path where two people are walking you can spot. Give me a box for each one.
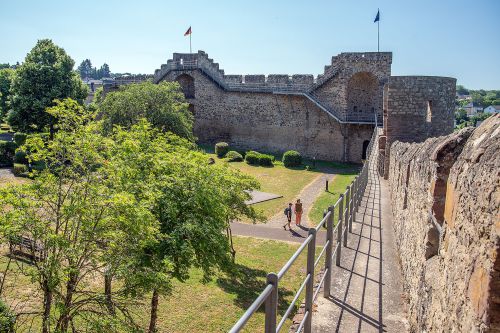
[231,172,335,243]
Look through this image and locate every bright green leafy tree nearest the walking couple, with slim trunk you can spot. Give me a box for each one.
[104,120,258,333]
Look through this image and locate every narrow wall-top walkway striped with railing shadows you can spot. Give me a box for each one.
[313,147,408,333]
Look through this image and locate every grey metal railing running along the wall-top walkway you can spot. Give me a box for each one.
[229,124,377,333]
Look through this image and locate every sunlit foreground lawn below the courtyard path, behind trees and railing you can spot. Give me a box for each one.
[0,237,306,332]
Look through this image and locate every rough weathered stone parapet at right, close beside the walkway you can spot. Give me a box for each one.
[386,115,500,332]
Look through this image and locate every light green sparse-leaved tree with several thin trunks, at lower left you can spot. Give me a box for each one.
[0,100,156,333]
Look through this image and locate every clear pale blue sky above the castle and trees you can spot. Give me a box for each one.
[0,0,500,89]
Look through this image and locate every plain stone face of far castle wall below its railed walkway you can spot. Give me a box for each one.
[164,70,373,162]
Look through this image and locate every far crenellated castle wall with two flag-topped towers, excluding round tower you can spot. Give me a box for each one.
[154,51,392,162]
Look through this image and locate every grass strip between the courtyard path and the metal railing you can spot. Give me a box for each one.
[309,170,357,224]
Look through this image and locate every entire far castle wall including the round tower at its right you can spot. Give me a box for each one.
[154,51,455,162]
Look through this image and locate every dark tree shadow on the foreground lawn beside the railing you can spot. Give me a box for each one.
[217,264,298,314]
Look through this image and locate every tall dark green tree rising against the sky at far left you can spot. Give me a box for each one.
[8,39,88,133]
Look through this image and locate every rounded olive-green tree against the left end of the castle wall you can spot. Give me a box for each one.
[99,82,194,141]
